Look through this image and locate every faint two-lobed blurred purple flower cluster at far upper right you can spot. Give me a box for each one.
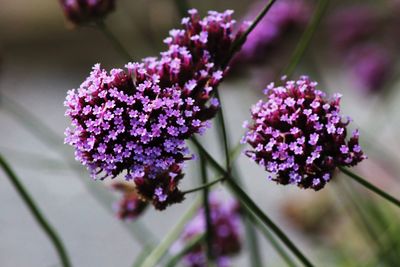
[330,5,393,92]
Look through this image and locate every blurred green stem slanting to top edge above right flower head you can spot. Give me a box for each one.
[283,0,329,77]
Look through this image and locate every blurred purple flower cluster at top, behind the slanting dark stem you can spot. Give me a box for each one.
[238,0,310,61]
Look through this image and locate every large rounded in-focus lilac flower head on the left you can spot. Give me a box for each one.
[65,62,196,207]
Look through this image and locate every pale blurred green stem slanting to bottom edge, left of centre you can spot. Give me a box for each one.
[140,198,200,267]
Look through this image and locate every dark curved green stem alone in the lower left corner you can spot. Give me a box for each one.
[0,155,71,267]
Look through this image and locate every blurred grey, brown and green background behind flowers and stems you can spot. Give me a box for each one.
[0,0,400,267]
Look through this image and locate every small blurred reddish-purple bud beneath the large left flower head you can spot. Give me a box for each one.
[112,182,148,220]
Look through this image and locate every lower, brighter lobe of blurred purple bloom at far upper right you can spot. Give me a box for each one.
[348,44,392,92]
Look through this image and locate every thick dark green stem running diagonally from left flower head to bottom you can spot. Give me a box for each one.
[191,138,313,266]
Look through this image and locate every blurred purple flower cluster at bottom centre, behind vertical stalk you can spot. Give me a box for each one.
[176,194,242,267]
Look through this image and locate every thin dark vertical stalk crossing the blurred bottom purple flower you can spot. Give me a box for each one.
[200,155,214,263]
